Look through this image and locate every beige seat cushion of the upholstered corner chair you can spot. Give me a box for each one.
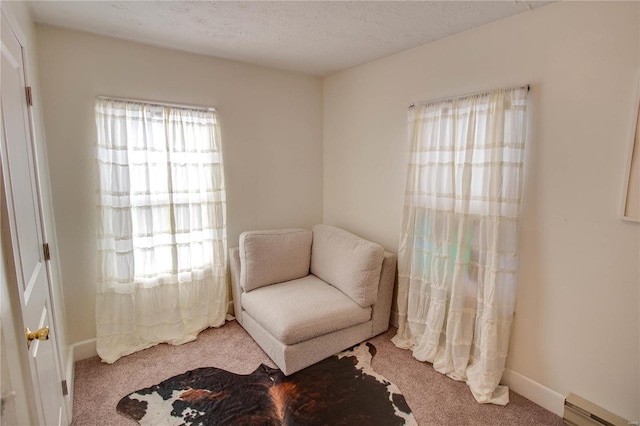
[242,275,371,345]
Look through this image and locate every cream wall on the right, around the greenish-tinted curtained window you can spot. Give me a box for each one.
[324,2,640,420]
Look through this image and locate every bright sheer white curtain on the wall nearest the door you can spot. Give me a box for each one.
[95,98,228,363]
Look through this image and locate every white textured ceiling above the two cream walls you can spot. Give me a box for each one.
[31,0,549,75]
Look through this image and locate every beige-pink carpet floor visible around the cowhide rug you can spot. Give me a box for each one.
[72,321,562,426]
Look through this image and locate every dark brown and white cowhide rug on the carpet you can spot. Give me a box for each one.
[117,343,417,426]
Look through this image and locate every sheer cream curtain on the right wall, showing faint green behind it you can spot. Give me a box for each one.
[393,87,528,405]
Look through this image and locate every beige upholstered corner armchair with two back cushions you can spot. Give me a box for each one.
[229,225,396,375]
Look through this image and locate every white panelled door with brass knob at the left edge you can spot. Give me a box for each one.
[0,14,67,425]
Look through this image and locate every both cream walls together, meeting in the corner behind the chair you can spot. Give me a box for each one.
[35,2,640,420]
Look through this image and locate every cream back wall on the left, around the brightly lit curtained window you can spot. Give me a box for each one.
[37,26,322,342]
